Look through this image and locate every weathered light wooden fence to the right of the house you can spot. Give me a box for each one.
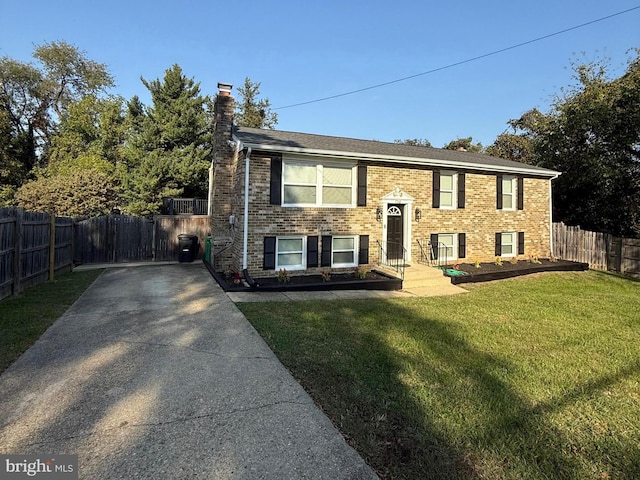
[553,223,640,275]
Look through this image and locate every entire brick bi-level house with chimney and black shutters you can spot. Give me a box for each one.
[211,84,559,277]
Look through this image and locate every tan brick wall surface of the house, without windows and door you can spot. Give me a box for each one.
[212,91,550,276]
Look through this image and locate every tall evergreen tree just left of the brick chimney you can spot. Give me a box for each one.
[125,64,213,216]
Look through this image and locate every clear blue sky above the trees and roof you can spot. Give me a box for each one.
[0,0,640,147]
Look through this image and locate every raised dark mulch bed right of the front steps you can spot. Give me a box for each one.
[445,259,589,285]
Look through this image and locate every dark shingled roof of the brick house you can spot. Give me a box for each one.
[233,126,560,178]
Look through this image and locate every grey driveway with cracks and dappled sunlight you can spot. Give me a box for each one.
[0,264,377,479]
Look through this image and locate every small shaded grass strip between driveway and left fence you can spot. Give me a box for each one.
[0,270,102,372]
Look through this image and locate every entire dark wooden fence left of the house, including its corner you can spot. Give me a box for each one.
[0,208,211,299]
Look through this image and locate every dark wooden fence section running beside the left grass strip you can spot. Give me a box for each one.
[0,208,73,299]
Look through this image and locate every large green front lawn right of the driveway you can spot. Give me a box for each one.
[239,272,640,480]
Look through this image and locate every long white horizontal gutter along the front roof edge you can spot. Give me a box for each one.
[240,143,559,179]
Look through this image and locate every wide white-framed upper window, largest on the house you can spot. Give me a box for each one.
[282,160,357,207]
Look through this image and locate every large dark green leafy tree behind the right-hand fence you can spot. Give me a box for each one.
[514,52,640,236]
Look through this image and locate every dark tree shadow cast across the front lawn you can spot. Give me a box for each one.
[249,302,640,480]
